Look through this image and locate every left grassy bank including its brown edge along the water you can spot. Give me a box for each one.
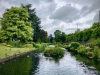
[0,43,36,64]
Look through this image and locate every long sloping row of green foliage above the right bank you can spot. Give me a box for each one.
[66,22,100,42]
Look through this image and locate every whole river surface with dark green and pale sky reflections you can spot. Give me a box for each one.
[0,51,100,75]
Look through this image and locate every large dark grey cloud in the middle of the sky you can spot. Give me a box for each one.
[50,4,80,22]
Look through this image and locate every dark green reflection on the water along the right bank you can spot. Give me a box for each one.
[71,52,100,75]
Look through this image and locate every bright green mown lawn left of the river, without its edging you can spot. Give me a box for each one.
[0,44,35,59]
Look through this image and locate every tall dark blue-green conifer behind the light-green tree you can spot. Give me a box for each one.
[21,4,41,42]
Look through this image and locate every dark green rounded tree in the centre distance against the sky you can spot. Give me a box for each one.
[54,30,66,42]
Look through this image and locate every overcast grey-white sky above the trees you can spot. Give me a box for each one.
[0,0,100,34]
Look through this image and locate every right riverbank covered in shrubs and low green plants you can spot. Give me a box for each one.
[64,42,100,61]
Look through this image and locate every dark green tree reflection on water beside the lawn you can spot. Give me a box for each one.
[0,51,39,75]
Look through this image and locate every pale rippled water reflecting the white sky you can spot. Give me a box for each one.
[32,53,97,75]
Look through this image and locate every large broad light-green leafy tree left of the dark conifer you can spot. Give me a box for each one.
[0,7,33,42]
